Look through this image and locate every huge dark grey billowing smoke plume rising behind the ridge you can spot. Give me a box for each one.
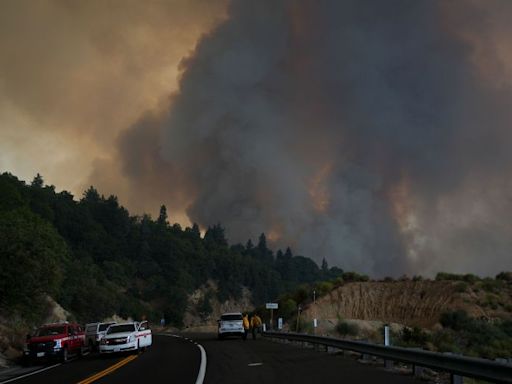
[120,0,512,276]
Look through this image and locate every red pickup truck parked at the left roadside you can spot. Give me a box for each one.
[23,323,85,364]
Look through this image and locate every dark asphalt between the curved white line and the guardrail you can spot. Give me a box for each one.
[189,334,418,384]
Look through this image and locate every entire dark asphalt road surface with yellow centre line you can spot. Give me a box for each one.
[0,334,419,384]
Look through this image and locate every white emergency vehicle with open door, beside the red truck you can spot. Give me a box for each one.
[100,321,153,353]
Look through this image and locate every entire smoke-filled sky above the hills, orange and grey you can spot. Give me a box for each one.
[0,0,512,277]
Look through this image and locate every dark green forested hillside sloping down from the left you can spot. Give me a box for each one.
[0,173,343,326]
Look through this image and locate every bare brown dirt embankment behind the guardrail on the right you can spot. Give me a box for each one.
[304,280,510,328]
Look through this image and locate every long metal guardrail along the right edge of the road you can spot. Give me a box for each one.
[263,332,512,383]
